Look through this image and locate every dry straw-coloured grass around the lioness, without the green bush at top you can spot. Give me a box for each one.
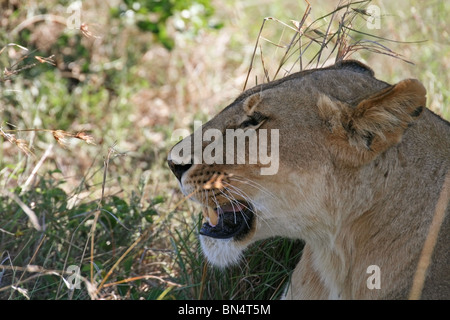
[0,0,450,299]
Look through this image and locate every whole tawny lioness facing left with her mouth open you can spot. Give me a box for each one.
[168,60,450,299]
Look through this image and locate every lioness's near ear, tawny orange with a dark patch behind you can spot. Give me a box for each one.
[319,79,426,166]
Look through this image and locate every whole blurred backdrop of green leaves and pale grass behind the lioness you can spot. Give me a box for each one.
[0,0,450,299]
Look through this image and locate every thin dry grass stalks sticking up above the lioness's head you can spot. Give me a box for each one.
[244,0,421,90]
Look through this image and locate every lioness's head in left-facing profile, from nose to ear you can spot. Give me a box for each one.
[168,61,448,300]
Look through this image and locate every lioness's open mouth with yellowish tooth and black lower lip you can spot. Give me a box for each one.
[200,202,254,239]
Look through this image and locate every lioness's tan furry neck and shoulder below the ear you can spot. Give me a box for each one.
[303,112,450,299]
